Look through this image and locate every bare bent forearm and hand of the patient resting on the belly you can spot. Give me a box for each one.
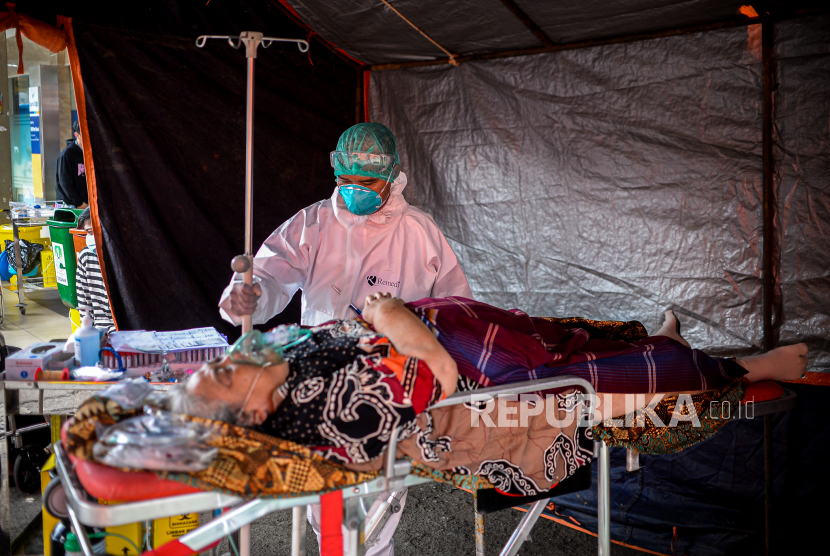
[362,293,458,396]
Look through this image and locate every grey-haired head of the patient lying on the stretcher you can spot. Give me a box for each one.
[168,356,288,426]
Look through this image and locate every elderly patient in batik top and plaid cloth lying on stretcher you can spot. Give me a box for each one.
[170,294,807,482]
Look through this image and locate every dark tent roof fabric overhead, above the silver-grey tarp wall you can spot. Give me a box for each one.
[281,0,769,64]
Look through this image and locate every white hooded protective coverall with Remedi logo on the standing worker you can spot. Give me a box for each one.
[219,172,472,326]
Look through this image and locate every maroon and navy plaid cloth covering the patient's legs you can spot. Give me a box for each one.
[407,297,746,393]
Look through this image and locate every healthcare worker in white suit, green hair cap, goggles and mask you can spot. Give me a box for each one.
[219,123,472,556]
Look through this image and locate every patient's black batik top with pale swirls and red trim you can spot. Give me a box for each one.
[258,320,440,463]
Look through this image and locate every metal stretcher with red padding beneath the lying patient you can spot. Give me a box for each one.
[52,376,796,556]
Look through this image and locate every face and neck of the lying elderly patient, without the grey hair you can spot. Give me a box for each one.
[185,357,288,424]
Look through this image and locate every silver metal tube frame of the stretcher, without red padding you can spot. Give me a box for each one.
[55,376,611,556]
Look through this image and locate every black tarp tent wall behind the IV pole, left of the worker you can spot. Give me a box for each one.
[20,0,357,338]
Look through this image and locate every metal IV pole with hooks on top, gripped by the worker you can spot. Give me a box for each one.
[196,31,308,334]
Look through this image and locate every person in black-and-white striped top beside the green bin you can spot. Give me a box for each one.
[75,207,115,334]
